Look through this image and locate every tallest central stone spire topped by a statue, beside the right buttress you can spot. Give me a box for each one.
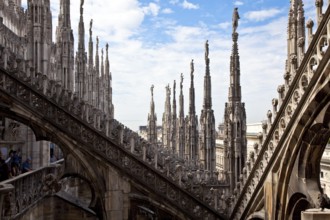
[224,8,247,192]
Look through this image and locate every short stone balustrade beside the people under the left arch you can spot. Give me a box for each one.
[0,161,63,220]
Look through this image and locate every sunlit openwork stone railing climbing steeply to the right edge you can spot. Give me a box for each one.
[230,2,330,219]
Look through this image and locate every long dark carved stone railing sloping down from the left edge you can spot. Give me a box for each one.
[0,63,223,219]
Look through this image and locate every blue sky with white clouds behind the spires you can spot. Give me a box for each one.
[25,0,315,130]
